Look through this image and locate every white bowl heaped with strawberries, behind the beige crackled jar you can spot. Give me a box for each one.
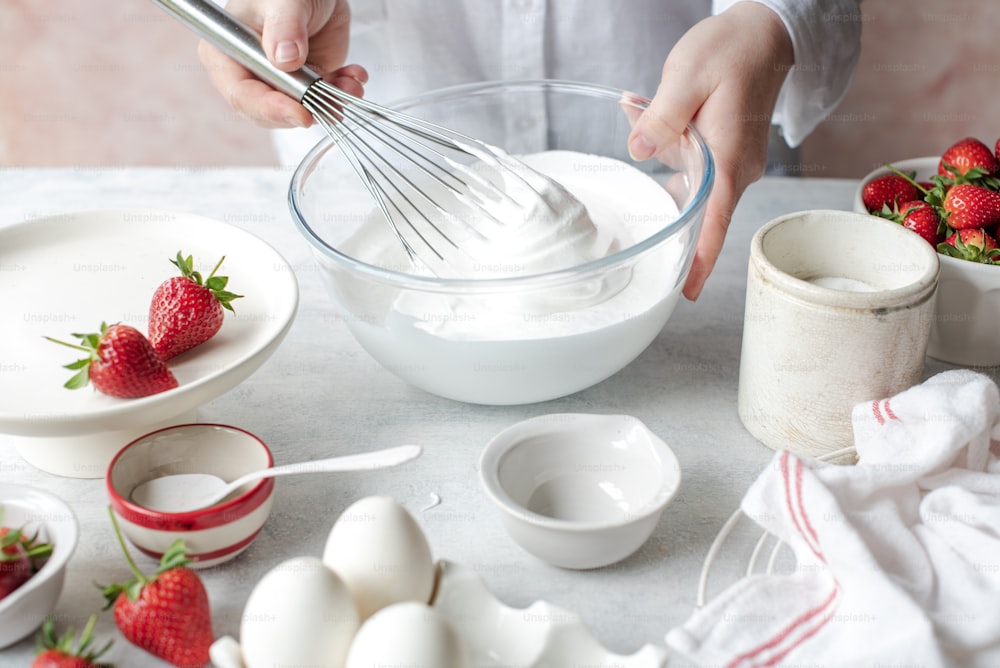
[854,137,1000,367]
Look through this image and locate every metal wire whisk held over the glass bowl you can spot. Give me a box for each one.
[146,0,583,276]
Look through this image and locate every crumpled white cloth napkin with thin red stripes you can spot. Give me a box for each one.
[666,370,1000,668]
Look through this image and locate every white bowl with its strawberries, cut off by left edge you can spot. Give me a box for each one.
[0,482,80,648]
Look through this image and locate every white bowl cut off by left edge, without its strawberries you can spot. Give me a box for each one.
[0,482,80,648]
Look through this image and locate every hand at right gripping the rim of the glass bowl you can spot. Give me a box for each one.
[628,2,794,301]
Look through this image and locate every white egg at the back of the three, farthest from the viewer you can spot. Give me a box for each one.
[323,496,434,620]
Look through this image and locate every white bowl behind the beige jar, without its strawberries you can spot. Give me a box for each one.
[854,156,1000,367]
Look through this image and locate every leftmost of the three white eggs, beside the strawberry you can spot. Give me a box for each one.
[240,557,361,668]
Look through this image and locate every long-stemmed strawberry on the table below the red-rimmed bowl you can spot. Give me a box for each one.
[102,508,214,668]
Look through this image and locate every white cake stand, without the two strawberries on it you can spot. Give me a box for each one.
[0,209,298,478]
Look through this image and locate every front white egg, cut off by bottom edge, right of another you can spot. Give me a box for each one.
[345,603,467,668]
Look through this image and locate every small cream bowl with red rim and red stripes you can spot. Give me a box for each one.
[105,424,274,568]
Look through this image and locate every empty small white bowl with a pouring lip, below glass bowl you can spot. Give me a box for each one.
[479,413,681,569]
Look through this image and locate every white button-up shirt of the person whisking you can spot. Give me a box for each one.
[275,0,862,165]
